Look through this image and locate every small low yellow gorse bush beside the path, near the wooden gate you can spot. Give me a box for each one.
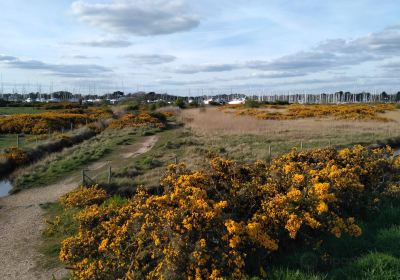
[60,186,108,207]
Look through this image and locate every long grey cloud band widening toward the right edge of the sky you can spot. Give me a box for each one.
[168,25,400,78]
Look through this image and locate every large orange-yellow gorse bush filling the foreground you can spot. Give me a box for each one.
[60,146,400,279]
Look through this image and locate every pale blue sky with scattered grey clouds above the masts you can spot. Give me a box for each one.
[0,0,400,95]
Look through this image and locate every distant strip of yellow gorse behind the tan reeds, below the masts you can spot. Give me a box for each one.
[221,104,395,122]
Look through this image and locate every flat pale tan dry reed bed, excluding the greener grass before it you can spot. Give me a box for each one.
[179,107,400,139]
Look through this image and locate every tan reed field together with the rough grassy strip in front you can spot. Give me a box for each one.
[178,107,400,159]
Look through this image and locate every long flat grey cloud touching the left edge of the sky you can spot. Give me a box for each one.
[0,56,112,78]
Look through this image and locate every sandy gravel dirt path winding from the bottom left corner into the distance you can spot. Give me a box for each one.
[0,136,158,280]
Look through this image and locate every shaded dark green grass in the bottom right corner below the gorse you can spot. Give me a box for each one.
[271,206,400,280]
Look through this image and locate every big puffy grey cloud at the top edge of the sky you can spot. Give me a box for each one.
[72,0,199,36]
